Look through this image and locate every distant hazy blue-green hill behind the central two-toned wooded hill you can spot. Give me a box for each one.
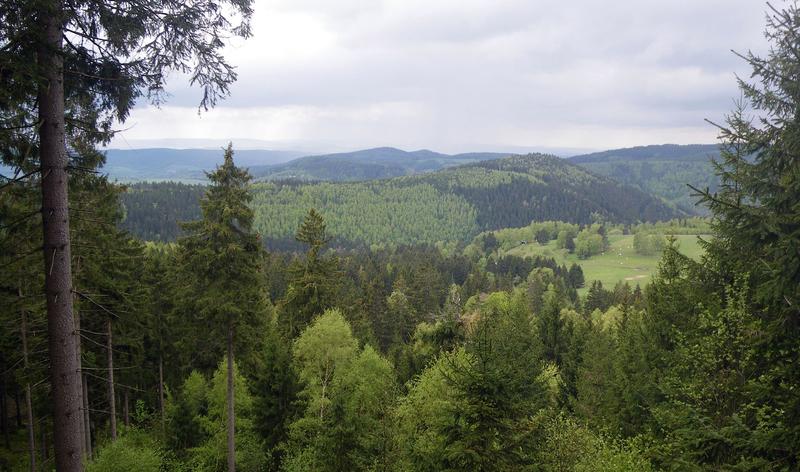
[250,147,508,181]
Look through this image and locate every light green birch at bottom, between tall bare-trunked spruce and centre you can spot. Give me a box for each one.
[285,310,396,471]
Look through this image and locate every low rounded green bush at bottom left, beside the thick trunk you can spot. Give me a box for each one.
[86,430,162,472]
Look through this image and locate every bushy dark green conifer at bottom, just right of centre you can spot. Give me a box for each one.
[443,294,544,470]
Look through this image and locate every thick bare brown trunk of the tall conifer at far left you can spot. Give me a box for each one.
[38,0,83,472]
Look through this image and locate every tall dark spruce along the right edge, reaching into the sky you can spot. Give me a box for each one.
[672,2,800,470]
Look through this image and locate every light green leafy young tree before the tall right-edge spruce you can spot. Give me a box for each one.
[656,278,784,471]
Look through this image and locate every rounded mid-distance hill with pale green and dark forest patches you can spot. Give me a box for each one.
[123,154,681,247]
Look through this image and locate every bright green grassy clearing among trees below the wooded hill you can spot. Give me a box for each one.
[506,234,708,294]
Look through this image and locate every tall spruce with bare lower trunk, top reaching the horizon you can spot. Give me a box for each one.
[178,144,264,472]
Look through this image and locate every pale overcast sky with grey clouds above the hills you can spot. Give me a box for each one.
[112,0,780,153]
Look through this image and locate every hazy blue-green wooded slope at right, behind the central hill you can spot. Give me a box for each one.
[570,144,719,213]
